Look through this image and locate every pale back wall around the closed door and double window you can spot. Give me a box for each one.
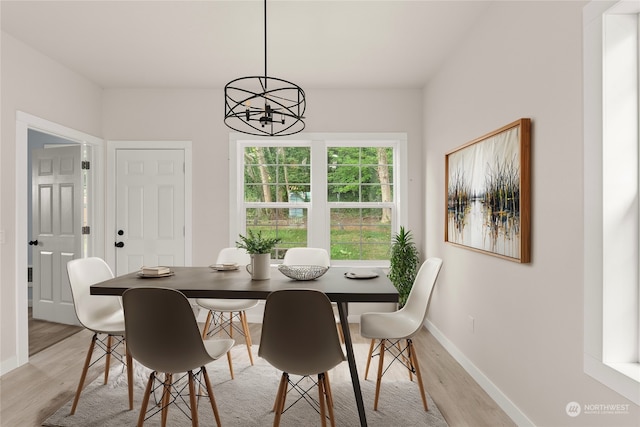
[103,87,424,265]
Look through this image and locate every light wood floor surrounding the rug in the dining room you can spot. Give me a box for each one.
[0,324,515,427]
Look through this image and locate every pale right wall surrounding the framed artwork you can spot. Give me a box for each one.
[424,2,640,426]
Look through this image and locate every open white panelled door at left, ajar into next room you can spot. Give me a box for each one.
[29,145,84,324]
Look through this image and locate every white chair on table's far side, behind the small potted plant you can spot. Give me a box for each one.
[196,247,258,379]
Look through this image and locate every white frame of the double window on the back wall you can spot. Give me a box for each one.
[229,133,408,268]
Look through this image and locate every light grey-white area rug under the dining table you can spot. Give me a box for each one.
[43,344,447,427]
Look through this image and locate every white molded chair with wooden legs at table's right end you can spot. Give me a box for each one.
[360,258,442,411]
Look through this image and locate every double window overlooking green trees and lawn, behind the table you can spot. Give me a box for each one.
[230,134,406,266]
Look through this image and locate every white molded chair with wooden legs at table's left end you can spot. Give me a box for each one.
[67,257,133,415]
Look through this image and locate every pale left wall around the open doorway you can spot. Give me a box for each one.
[0,33,101,372]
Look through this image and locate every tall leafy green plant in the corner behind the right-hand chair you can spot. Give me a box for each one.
[387,227,420,308]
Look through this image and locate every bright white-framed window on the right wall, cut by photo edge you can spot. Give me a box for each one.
[583,0,640,404]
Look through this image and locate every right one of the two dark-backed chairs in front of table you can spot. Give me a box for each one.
[258,289,345,426]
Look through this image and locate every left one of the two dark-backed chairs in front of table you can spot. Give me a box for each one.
[122,288,234,426]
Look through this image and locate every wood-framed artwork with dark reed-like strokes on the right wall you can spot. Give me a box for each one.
[444,118,531,263]
